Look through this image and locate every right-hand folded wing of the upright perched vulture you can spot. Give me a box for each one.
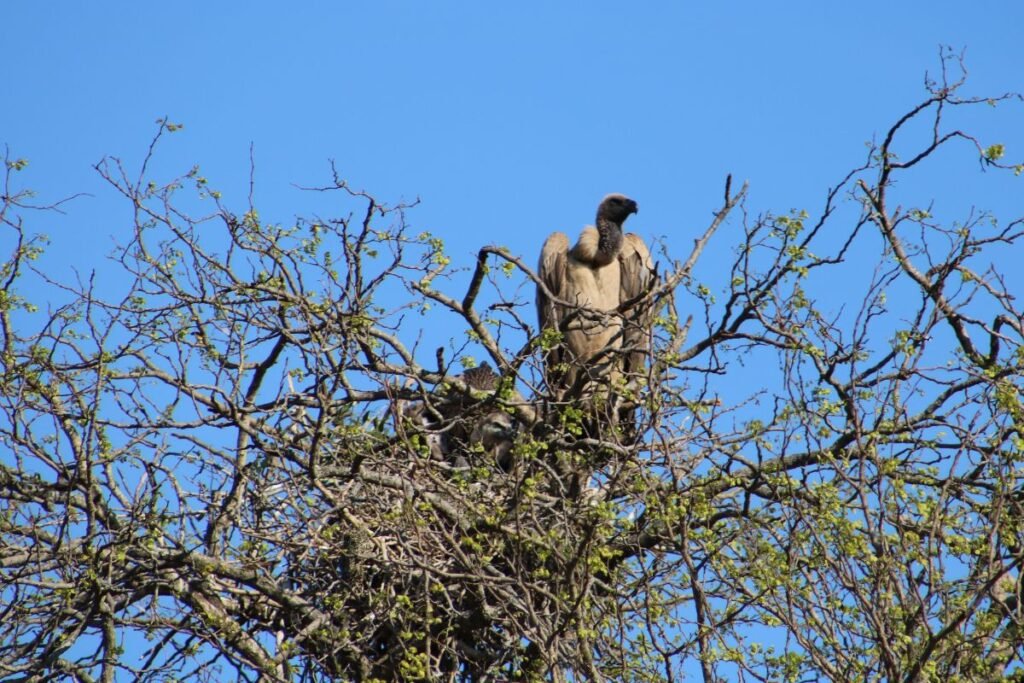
[618,232,654,377]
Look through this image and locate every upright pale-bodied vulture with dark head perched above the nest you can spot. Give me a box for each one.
[537,195,654,392]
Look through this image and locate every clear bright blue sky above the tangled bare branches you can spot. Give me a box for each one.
[0,0,1024,335]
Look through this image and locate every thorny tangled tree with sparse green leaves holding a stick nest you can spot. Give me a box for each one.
[0,54,1024,682]
